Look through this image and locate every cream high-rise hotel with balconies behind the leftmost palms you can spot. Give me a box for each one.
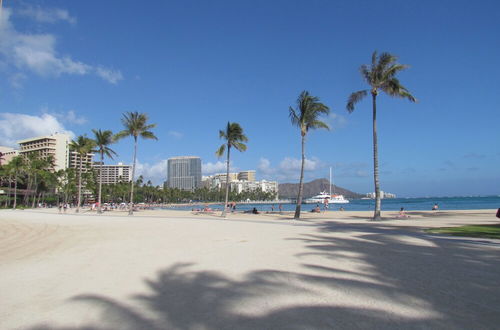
[17,133,70,171]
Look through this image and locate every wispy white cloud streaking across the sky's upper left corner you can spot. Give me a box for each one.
[0,8,123,87]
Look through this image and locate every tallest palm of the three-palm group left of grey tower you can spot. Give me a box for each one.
[115,111,158,215]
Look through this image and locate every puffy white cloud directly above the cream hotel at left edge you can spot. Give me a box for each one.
[0,112,75,148]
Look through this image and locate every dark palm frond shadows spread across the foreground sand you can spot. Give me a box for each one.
[31,224,500,330]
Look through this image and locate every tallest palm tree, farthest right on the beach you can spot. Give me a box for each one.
[346,51,417,220]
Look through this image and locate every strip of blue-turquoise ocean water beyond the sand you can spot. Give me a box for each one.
[164,196,500,212]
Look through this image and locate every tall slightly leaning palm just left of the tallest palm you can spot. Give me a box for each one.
[289,91,330,219]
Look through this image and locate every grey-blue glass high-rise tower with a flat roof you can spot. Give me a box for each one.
[167,156,201,191]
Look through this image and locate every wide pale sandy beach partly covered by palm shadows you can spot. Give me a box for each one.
[0,209,500,329]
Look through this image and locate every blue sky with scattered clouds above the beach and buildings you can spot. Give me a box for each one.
[0,0,500,197]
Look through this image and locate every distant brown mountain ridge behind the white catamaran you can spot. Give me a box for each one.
[279,179,364,199]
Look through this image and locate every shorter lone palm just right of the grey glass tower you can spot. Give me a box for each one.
[215,122,248,217]
